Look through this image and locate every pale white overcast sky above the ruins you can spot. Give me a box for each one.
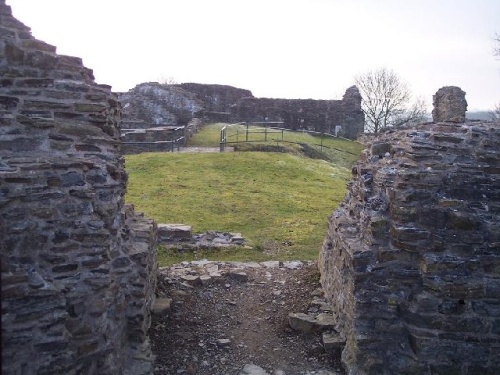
[7,0,500,110]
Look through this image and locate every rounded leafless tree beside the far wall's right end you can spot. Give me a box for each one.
[355,68,425,133]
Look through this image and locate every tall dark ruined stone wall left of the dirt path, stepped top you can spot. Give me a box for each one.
[0,0,157,374]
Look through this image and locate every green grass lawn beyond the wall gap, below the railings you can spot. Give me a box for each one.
[126,123,360,264]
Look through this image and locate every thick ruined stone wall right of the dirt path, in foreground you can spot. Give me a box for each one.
[319,122,500,375]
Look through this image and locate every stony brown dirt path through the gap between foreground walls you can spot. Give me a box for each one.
[150,262,342,375]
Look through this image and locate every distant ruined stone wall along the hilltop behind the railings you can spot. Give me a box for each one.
[119,82,365,153]
